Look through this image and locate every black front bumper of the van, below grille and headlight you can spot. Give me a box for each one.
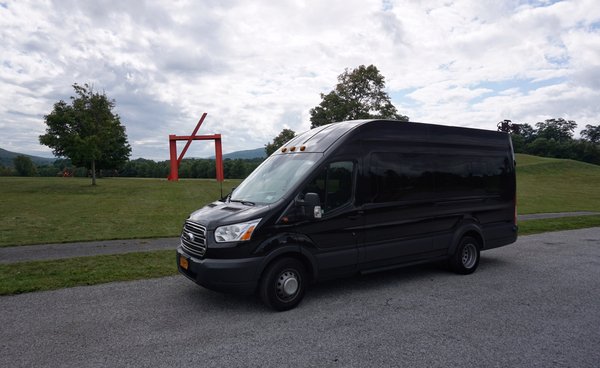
[177,246,263,294]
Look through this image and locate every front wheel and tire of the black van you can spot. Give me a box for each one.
[259,258,308,311]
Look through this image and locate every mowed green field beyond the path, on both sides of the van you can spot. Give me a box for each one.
[0,155,600,247]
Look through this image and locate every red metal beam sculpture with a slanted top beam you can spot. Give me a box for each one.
[168,113,223,182]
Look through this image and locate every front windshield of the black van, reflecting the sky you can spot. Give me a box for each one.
[231,153,322,204]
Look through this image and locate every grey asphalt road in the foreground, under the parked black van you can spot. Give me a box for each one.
[0,228,600,368]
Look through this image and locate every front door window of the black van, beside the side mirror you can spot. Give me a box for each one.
[302,161,354,213]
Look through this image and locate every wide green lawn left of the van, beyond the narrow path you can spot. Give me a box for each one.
[0,177,240,246]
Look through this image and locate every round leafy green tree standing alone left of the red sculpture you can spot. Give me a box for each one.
[40,83,131,185]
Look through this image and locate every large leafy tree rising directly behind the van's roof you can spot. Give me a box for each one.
[310,65,408,128]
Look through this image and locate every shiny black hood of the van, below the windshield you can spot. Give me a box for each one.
[189,201,270,230]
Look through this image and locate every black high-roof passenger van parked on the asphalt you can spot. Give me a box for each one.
[177,120,517,310]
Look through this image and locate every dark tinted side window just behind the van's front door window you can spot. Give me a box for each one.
[367,152,434,203]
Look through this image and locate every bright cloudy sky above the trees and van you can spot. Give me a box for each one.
[0,0,600,160]
